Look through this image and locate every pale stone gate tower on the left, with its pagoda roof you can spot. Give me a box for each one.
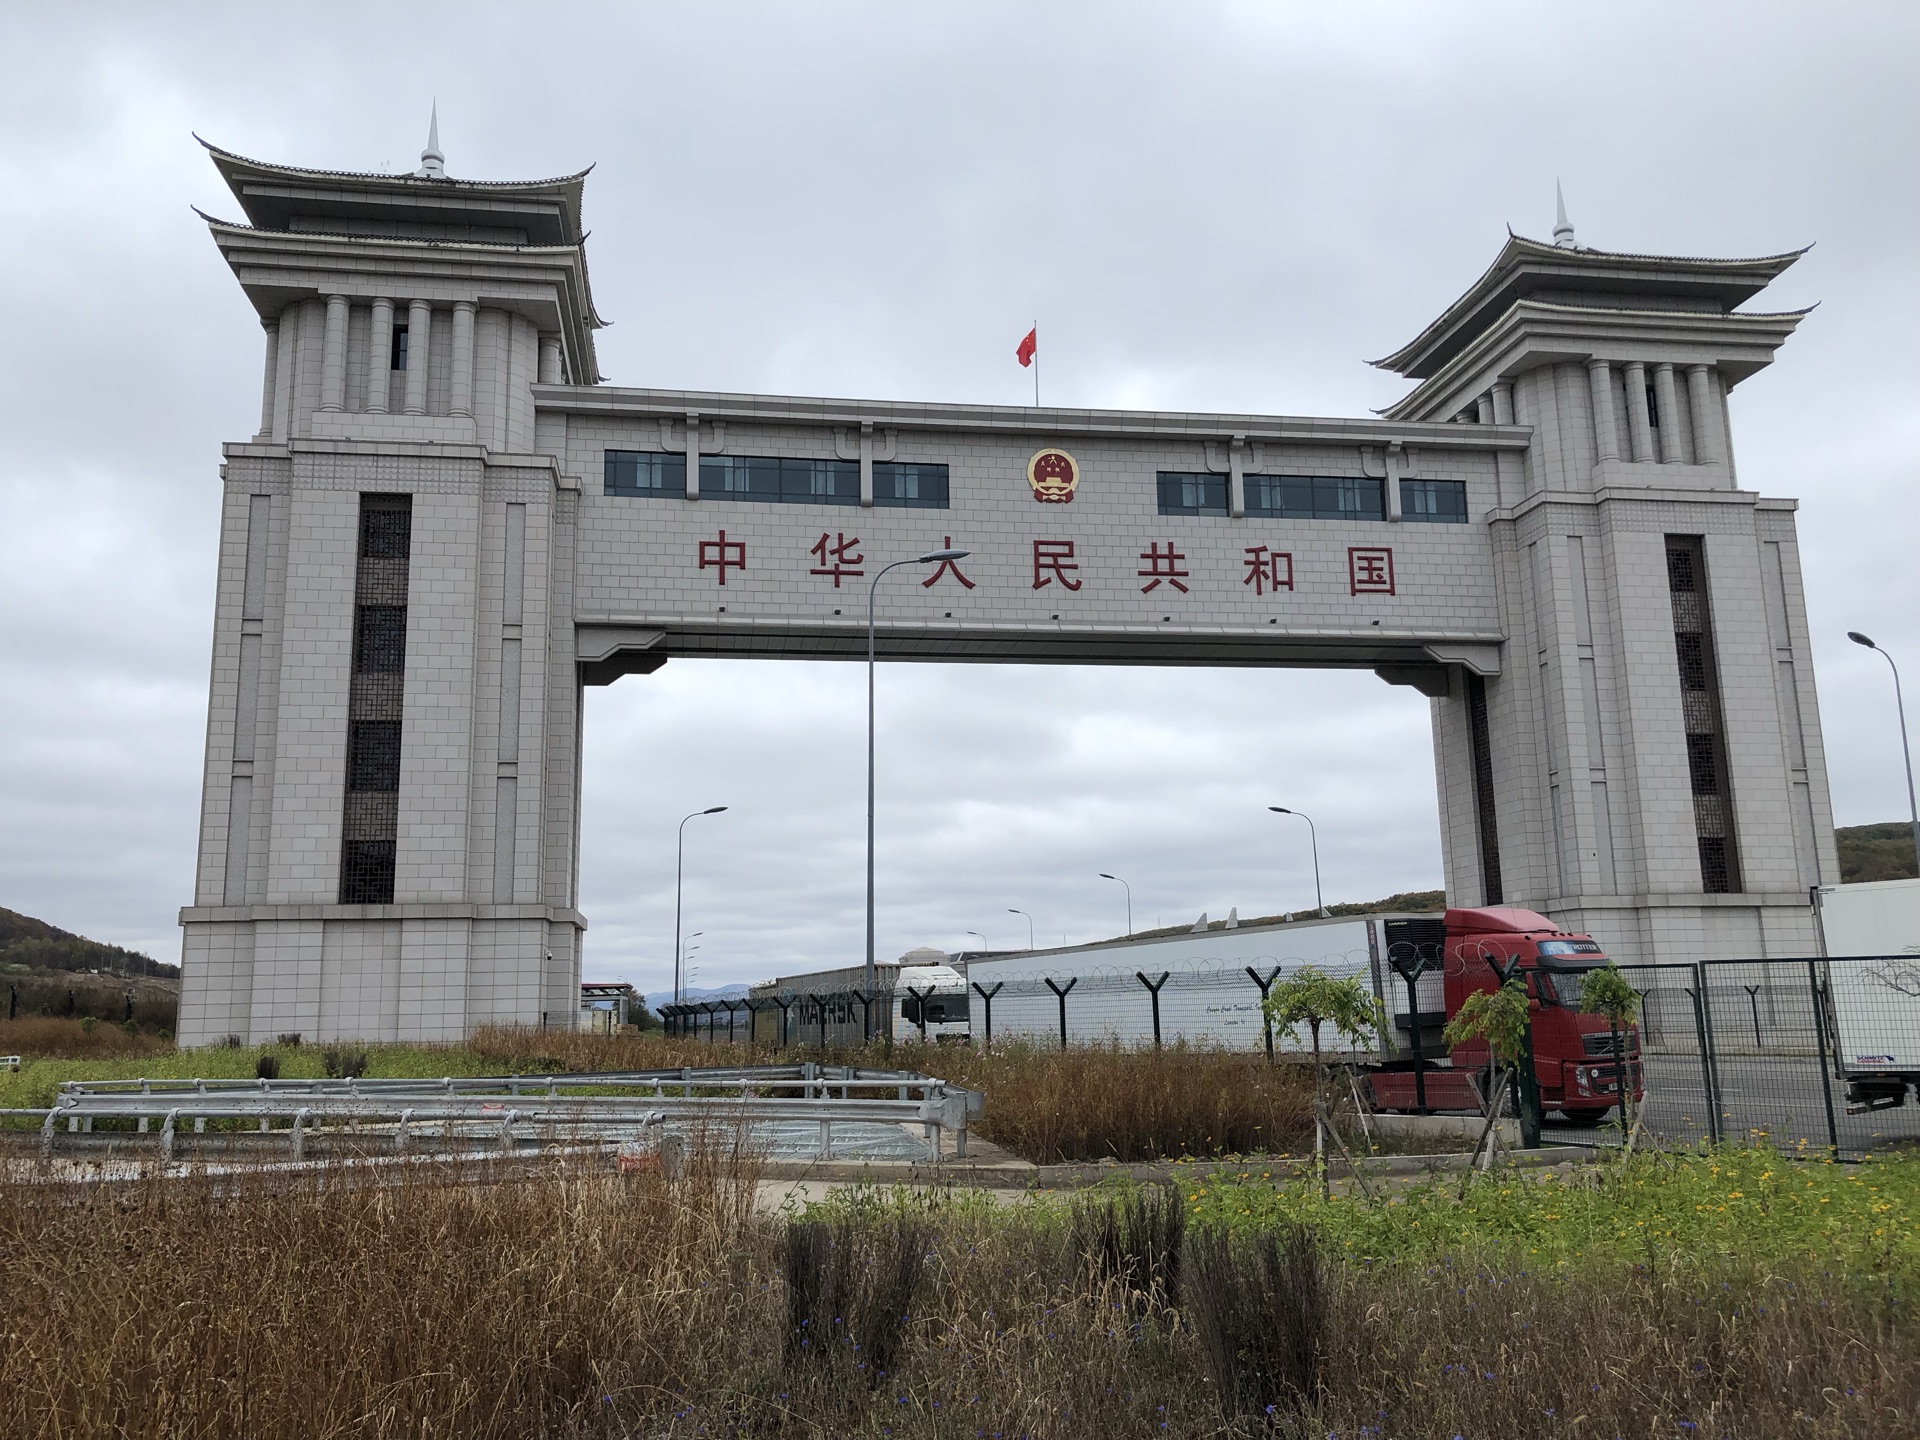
[180,125,599,1044]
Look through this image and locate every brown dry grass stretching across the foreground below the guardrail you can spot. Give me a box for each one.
[0,1152,1920,1440]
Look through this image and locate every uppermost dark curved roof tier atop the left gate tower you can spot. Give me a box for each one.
[194,134,593,246]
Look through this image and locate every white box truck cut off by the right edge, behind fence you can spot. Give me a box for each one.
[1812,879,1920,1114]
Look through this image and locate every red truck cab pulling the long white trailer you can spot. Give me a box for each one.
[1373,906,1642,1123]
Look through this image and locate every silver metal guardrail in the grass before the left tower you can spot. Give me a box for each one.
[33,1064,983,1164]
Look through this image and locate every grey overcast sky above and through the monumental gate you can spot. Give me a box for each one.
[0,0,1920,989]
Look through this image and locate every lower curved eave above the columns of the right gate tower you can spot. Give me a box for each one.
[1379,300,1818,424]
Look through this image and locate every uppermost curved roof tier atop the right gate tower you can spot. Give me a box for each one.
[1373,230,1812,380]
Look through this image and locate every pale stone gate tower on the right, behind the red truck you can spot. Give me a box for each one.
[1377,207,1837,960]
